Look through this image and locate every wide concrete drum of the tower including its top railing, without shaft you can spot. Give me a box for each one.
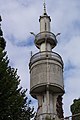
[29,51,64,98]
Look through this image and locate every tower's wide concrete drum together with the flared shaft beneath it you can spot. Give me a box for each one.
[29,51,64,120]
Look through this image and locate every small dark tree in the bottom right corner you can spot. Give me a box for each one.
[70,98,80,120]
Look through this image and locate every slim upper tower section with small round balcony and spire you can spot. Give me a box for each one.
[35,2,57,51]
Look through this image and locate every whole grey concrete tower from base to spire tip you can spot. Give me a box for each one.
[29,2,64,120]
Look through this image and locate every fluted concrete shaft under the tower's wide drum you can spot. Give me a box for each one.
[36,91,60,120]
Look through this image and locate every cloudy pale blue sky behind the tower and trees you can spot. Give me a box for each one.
[0,0,80,116]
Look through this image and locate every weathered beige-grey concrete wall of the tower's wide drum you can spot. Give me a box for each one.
[30,59,64,92]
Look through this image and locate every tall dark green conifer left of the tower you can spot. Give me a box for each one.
[0,16,34,120]
